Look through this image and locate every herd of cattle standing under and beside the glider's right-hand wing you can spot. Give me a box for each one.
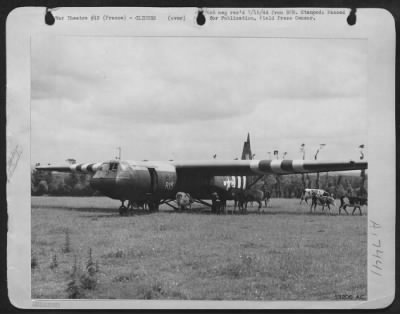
[130,189,368,215]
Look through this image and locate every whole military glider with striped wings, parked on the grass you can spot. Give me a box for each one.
[36,135,368,215]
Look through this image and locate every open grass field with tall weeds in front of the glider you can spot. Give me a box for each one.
[32,197,367,300]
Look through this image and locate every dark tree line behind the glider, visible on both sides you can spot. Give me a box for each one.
[31,169,368,198]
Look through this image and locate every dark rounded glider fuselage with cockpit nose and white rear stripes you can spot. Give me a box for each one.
[90,161,253,201]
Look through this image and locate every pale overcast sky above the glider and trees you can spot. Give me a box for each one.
[31,36,367,163]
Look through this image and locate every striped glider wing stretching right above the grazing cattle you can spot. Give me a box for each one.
[172,160,368,176]
